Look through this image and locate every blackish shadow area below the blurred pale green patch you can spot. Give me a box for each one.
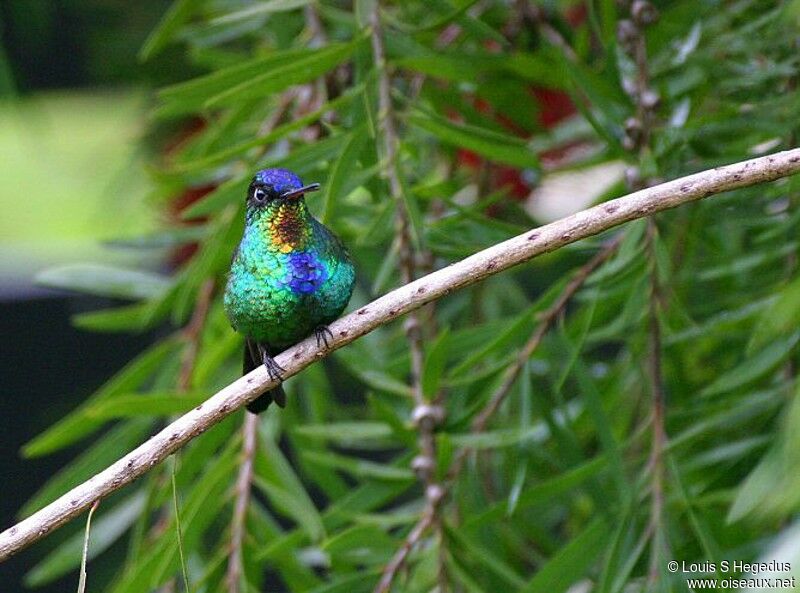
[0,295,152,593]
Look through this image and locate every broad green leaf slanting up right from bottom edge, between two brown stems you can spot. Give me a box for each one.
[520,519,609,593]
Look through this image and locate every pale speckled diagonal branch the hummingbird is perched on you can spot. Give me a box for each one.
[0,148,800,561]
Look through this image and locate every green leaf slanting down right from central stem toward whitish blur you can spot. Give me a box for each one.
[409,111,539,169]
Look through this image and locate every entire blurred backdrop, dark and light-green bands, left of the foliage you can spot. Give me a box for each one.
[0,0,170,593]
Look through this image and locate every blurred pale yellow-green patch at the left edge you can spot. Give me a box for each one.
[0,88,155,282]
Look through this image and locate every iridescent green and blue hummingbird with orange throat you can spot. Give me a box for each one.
[223,169,355,414]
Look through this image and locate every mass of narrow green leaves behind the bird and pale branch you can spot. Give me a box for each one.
[25,0,800,593]
